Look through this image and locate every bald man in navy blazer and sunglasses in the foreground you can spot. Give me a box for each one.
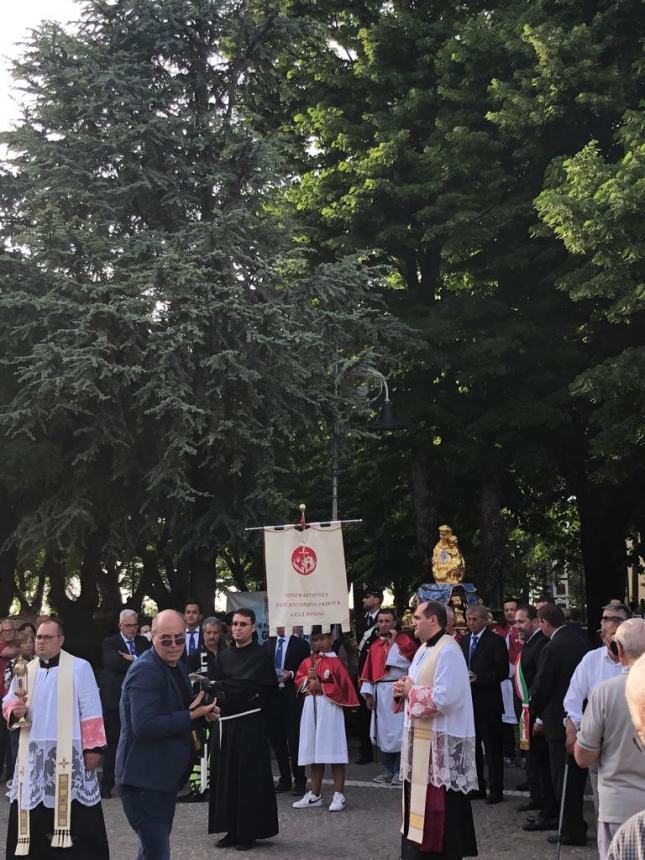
[116,609,219,860]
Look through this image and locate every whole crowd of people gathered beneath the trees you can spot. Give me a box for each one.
[0,588,645,860]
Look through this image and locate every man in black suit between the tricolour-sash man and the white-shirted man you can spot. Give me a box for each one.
[531,603,589,845]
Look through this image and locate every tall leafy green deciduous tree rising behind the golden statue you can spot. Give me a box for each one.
[272,0,643,616]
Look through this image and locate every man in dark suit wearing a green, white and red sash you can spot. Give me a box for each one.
[515,606,557,831]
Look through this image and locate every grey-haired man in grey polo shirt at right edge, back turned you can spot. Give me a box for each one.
[574,618,645,860]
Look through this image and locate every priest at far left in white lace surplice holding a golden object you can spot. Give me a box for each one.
[2,619,109,860]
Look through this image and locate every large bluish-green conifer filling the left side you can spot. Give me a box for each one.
[0,0,402,644]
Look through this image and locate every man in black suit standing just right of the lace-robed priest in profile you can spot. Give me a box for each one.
[459,606,508,803]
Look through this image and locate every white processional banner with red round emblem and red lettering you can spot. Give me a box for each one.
[264,522,349,633]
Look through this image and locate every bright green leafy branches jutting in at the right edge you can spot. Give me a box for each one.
[537,110,645,483]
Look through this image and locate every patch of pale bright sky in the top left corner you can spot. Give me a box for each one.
[0,0,80,130]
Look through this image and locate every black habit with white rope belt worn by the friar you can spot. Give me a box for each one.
[208,643,278,843]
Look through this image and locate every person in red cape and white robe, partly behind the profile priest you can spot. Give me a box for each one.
[359,609,417,785]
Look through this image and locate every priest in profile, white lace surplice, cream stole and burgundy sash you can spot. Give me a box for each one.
[392,601,477,860]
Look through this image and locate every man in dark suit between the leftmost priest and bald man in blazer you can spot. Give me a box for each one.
[101,609,150,798]
